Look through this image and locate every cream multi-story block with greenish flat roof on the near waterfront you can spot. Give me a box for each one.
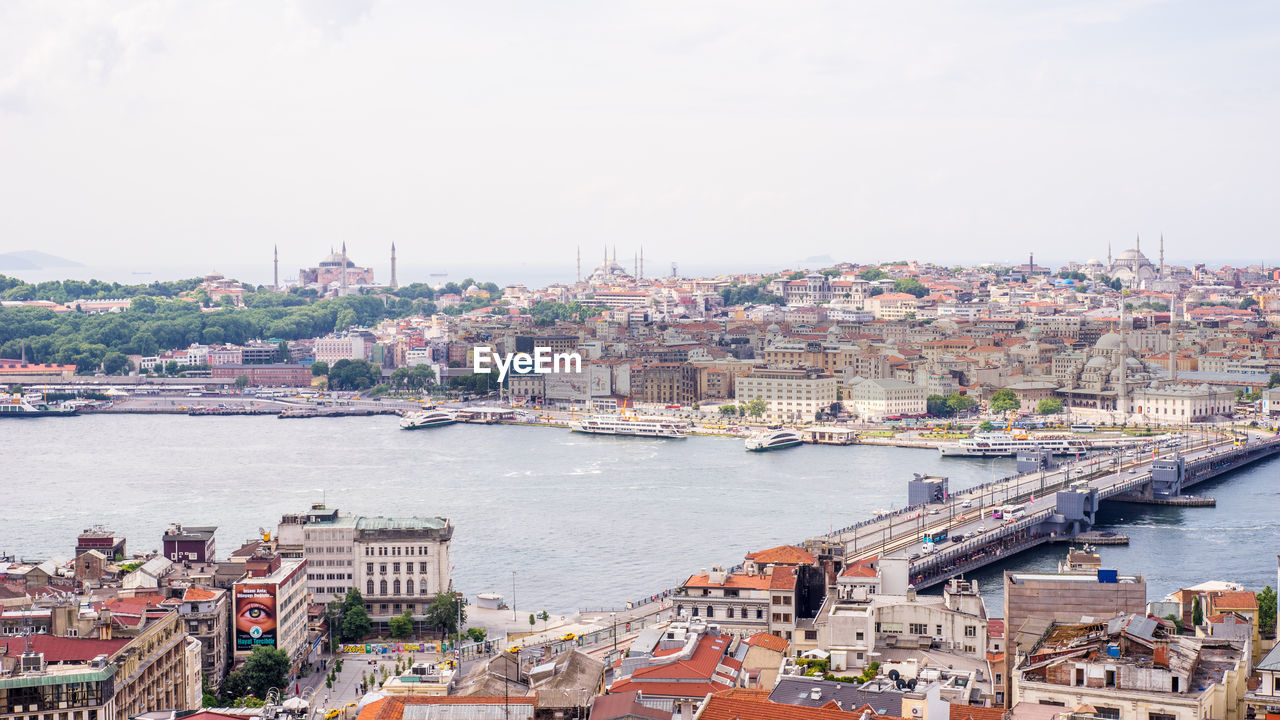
[276,505,453,620]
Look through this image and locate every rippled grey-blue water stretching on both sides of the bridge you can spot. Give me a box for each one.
[0,415,1280,614]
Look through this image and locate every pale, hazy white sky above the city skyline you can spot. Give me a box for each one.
[0,0,1280,282]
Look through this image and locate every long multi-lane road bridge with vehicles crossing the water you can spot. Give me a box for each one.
[810,427,1280,589]
